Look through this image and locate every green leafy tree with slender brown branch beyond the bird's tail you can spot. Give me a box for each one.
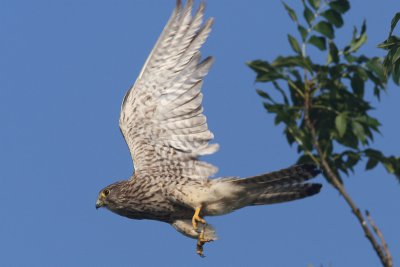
[248,0,400,266]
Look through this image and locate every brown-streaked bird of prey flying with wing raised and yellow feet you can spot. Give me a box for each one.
[96,0,321,256]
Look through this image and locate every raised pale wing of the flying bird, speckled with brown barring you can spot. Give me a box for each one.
[119,0,218,179]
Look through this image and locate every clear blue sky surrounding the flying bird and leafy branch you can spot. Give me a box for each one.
[0,0,400,266]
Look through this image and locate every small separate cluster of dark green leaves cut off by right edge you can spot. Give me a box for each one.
[378,12,400,85]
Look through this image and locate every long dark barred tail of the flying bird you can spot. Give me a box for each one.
[219,164,322,209]
